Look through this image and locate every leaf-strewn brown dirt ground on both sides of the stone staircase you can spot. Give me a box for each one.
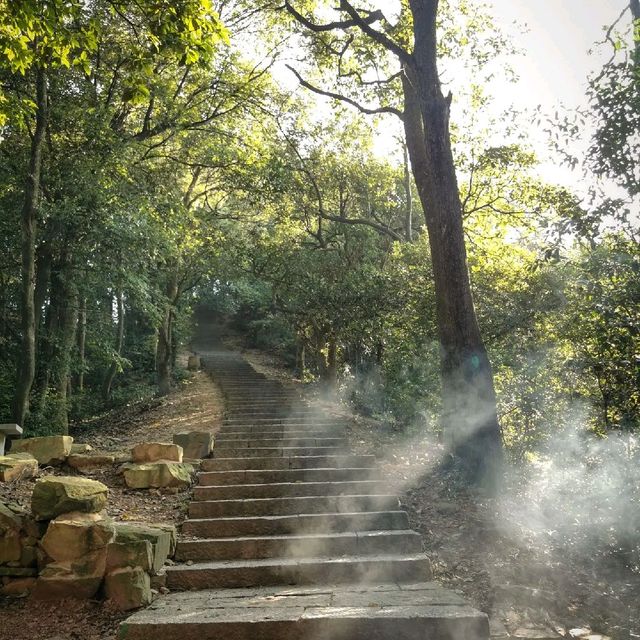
[0,334,640,640]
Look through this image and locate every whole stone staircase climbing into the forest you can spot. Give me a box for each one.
[120,350,489,640]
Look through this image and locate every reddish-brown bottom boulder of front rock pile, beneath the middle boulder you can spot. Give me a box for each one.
[33,549,107,600]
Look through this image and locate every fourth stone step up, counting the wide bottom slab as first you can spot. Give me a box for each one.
[182,511,409,538]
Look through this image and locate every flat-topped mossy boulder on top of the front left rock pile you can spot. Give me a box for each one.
[31,476,109,520]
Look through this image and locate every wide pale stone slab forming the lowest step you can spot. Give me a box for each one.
[119,583,489,640]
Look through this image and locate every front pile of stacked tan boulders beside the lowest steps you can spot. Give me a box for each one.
[0,476,176,610]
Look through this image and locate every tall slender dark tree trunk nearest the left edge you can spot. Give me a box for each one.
[13,68,47,425]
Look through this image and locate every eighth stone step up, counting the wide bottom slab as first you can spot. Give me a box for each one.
[200,455,376,471]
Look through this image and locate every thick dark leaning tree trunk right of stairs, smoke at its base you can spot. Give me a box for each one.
[404,0,502,483]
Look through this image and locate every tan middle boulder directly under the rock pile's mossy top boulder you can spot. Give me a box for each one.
[40,513,115,562]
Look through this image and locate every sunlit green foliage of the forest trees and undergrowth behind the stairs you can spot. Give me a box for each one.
[0,0,640,458]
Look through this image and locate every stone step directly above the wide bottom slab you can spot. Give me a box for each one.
[166,554,431,591]
